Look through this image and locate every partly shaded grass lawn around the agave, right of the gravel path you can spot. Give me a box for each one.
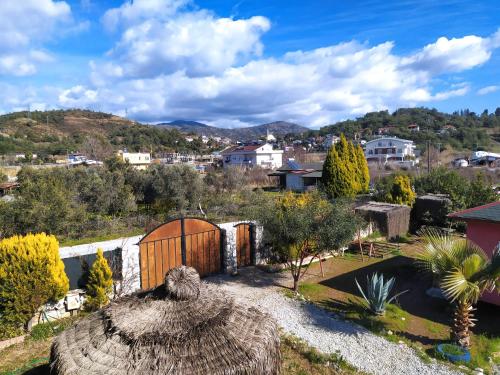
[292,239,500,369]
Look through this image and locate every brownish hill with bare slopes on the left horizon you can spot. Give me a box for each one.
[0,109,203,159]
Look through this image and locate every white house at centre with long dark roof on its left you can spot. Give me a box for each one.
[222,143,283,169]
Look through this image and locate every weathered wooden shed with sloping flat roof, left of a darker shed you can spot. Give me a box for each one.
[355,202,411,238]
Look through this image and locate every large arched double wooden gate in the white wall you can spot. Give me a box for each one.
[139,218,223,289]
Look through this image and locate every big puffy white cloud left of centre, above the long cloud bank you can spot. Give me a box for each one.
[100,12,270,78]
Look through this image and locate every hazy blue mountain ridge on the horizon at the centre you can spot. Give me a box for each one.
[156,120,309,141]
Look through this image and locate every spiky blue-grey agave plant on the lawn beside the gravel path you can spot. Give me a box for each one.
[354,272,408,315]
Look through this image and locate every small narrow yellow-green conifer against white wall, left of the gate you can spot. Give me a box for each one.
[85,249,113,310]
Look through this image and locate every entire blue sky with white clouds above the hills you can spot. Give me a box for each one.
[0,0,500,127]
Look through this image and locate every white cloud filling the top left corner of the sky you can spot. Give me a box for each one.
[0,0,71,76]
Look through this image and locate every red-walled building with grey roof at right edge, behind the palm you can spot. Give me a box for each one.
[448,201,500,306]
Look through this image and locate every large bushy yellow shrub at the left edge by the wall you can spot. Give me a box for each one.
[0,233,69,336]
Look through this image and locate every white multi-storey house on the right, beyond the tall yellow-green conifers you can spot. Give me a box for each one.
[365,137,415,163]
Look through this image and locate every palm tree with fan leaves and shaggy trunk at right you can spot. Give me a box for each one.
[417,231,500,348]
